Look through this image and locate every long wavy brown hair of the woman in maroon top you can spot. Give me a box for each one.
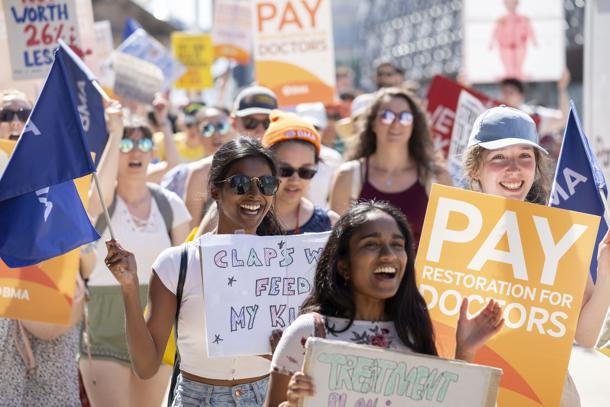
[348,88,439,185]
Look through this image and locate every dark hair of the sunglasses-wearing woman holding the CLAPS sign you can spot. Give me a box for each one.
[208,137,282,236]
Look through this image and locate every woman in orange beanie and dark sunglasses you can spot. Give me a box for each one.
[262,110,339,234]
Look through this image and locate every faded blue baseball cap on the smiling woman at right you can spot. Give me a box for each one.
[468,105,548,154]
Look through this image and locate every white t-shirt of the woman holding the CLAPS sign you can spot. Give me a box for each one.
[153,235,269,380]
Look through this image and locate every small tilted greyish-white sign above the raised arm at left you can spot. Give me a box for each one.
[113,52,163,103]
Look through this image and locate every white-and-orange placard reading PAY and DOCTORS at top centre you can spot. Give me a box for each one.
[252,0,335,106]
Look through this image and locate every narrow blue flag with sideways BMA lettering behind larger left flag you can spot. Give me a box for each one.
[58,40,108,165]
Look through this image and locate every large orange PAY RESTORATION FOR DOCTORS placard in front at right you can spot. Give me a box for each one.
[415,185,599,407]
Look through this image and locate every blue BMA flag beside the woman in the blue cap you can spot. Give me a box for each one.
[550,103,608,282]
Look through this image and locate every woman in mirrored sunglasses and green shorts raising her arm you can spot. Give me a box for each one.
[80,110,190,406]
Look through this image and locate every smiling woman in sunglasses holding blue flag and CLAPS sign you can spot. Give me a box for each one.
[106,137,281,407]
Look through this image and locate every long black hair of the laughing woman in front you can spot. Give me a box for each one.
[301,201,438,355]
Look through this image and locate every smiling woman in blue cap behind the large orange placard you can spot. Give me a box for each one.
[464,105,610,407]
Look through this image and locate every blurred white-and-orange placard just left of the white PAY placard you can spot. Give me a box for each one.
[212,0,252,64]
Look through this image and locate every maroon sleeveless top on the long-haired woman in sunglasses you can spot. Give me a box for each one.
[359,157,428,247]
